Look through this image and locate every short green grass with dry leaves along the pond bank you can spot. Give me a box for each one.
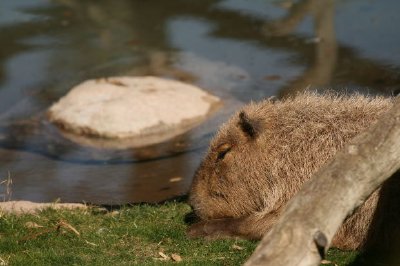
[0,202,372,265]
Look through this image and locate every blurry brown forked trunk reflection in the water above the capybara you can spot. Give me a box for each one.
[265,0,337,96]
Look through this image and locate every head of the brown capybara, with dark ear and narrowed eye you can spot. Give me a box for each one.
[190,105,276,219]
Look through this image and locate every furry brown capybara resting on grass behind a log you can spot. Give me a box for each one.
[188,92,400,249]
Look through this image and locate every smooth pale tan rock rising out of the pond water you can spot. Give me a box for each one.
[48,77,220,148]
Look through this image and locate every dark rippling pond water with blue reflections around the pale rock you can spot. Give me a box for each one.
[0,0,400,204]
